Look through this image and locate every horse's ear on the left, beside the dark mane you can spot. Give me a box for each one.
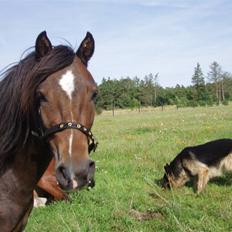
[35,31,52,58]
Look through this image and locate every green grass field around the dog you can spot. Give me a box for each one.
[26,105,232,232]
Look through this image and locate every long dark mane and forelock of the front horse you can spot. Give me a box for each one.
[0,45,75,168]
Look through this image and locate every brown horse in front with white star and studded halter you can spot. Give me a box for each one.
[0,32,97,232]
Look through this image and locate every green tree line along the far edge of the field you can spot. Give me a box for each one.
[96,61,232,111]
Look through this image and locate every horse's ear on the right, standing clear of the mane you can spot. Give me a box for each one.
[76,32,95,66]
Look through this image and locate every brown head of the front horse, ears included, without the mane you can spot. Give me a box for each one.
[35,32,97,190]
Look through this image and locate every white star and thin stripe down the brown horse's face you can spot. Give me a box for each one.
[59,70,75,156]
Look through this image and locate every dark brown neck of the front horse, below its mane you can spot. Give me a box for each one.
[0,137,51,231]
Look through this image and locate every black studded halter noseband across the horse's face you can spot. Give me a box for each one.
[32,122,98,153]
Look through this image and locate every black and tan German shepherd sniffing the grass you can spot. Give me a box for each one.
[162,139,232,193]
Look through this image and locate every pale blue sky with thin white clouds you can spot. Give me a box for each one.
[0,0,232,86]
